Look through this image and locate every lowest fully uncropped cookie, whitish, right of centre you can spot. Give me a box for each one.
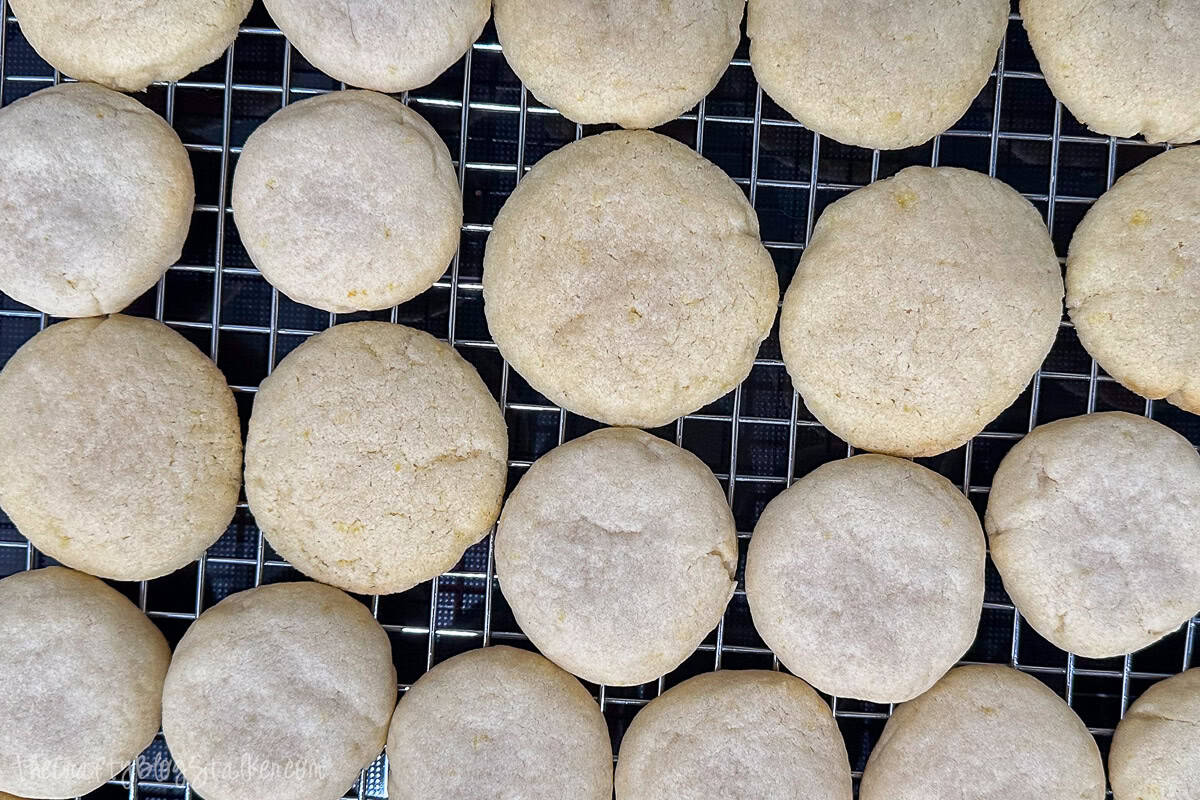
[745,456,985,703]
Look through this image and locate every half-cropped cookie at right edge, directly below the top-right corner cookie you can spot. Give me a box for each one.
[1067,144,1200,414]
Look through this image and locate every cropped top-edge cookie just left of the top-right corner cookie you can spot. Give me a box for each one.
[746,0,1008,150]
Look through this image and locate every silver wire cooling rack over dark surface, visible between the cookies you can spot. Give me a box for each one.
[0,0,1200,800]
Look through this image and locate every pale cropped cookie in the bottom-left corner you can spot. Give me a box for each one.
[0,567,170,798]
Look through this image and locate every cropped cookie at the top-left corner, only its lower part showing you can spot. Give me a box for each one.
[5,0,253,91]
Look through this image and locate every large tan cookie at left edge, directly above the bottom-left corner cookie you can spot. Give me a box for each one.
[0,314,241,581]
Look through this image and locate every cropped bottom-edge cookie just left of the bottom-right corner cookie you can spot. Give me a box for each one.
[859,664,1104,800]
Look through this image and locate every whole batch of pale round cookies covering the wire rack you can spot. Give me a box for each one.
[0,0,1200,800]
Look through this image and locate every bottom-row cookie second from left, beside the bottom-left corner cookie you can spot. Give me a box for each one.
[162,583,396,800]
